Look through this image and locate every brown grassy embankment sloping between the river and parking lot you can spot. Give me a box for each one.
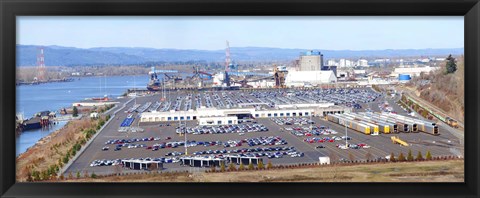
[16,107,111,181]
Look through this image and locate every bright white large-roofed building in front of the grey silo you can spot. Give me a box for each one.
[285,70,337,87]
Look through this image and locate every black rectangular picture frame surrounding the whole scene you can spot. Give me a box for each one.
[0,0,480,197]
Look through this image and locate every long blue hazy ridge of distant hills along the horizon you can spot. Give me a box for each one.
[17,45,463,66]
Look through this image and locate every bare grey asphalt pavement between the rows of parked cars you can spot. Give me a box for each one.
[66,89,463,174]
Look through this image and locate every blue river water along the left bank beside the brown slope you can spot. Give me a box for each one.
[16,75,148,156]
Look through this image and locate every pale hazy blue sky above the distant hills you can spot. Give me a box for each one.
[17,16,464,50]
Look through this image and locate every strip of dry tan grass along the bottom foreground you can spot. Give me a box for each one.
[65,159,464,182]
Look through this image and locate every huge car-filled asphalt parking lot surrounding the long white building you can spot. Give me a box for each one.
[66,89,463,174]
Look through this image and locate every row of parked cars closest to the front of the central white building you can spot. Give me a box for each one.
[181,124,268,135]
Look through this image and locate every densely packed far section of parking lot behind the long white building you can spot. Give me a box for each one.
[128,89,381,112]
